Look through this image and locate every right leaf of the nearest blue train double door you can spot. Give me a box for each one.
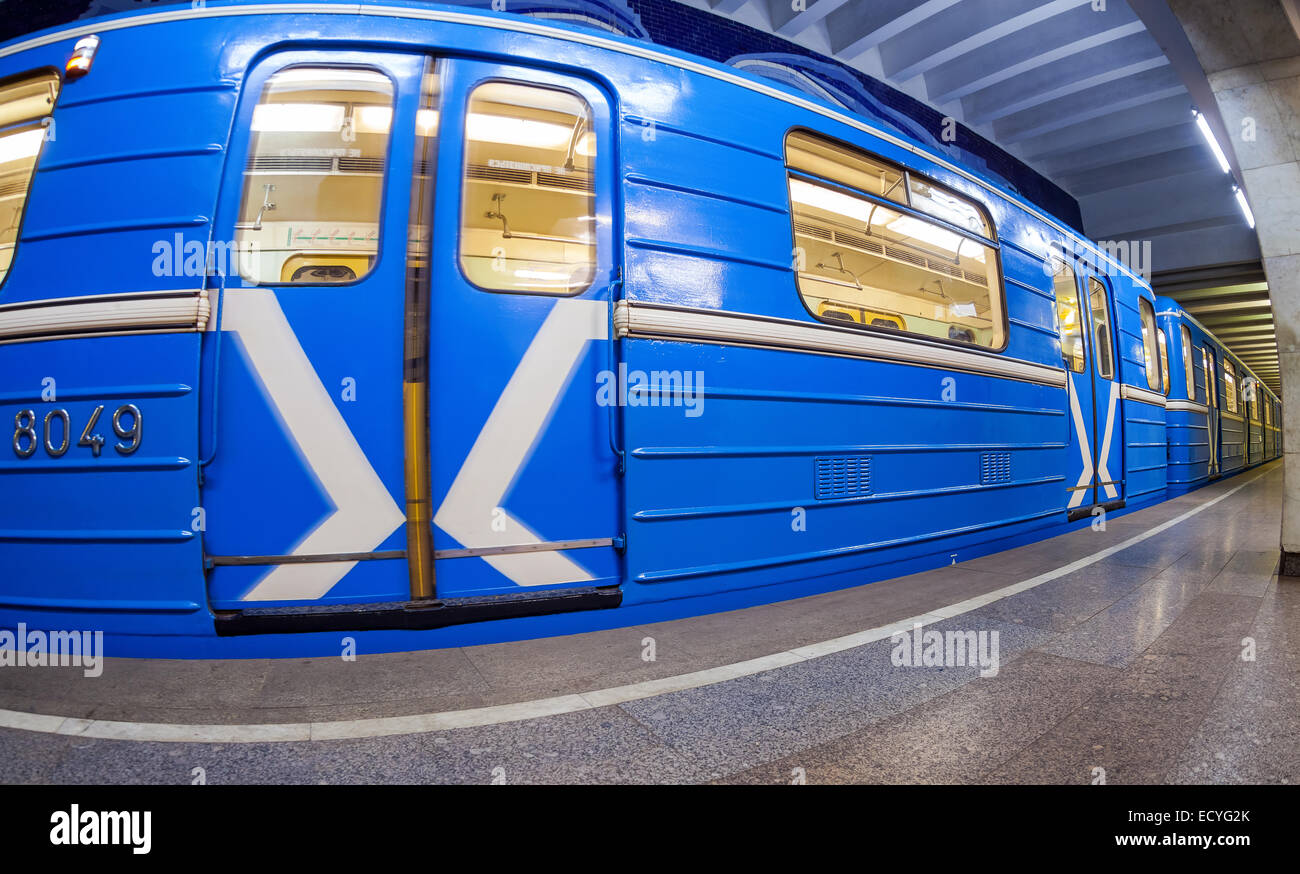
[425,60,621,598]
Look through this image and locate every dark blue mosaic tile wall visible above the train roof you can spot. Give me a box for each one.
[0,0,1083,229]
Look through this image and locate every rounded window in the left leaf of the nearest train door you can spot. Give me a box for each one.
[235,66,393,285]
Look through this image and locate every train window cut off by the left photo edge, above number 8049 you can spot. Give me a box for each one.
[0,70,60,282]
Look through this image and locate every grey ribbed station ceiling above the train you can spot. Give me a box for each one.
[677,0,1284,394]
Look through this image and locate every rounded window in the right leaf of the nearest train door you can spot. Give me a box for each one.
[460,82,597,294]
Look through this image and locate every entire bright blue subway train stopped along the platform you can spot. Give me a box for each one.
[0,1,1281,657]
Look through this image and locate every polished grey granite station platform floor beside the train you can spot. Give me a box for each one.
[0,462,1300,784]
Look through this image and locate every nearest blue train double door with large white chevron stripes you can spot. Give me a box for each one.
[205,49,621,613]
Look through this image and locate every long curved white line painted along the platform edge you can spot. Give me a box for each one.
[0,471,1271,744]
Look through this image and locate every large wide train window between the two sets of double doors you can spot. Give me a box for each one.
[785,131,1006,349]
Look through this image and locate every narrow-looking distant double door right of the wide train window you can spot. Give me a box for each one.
[1053,259,1125,519]
